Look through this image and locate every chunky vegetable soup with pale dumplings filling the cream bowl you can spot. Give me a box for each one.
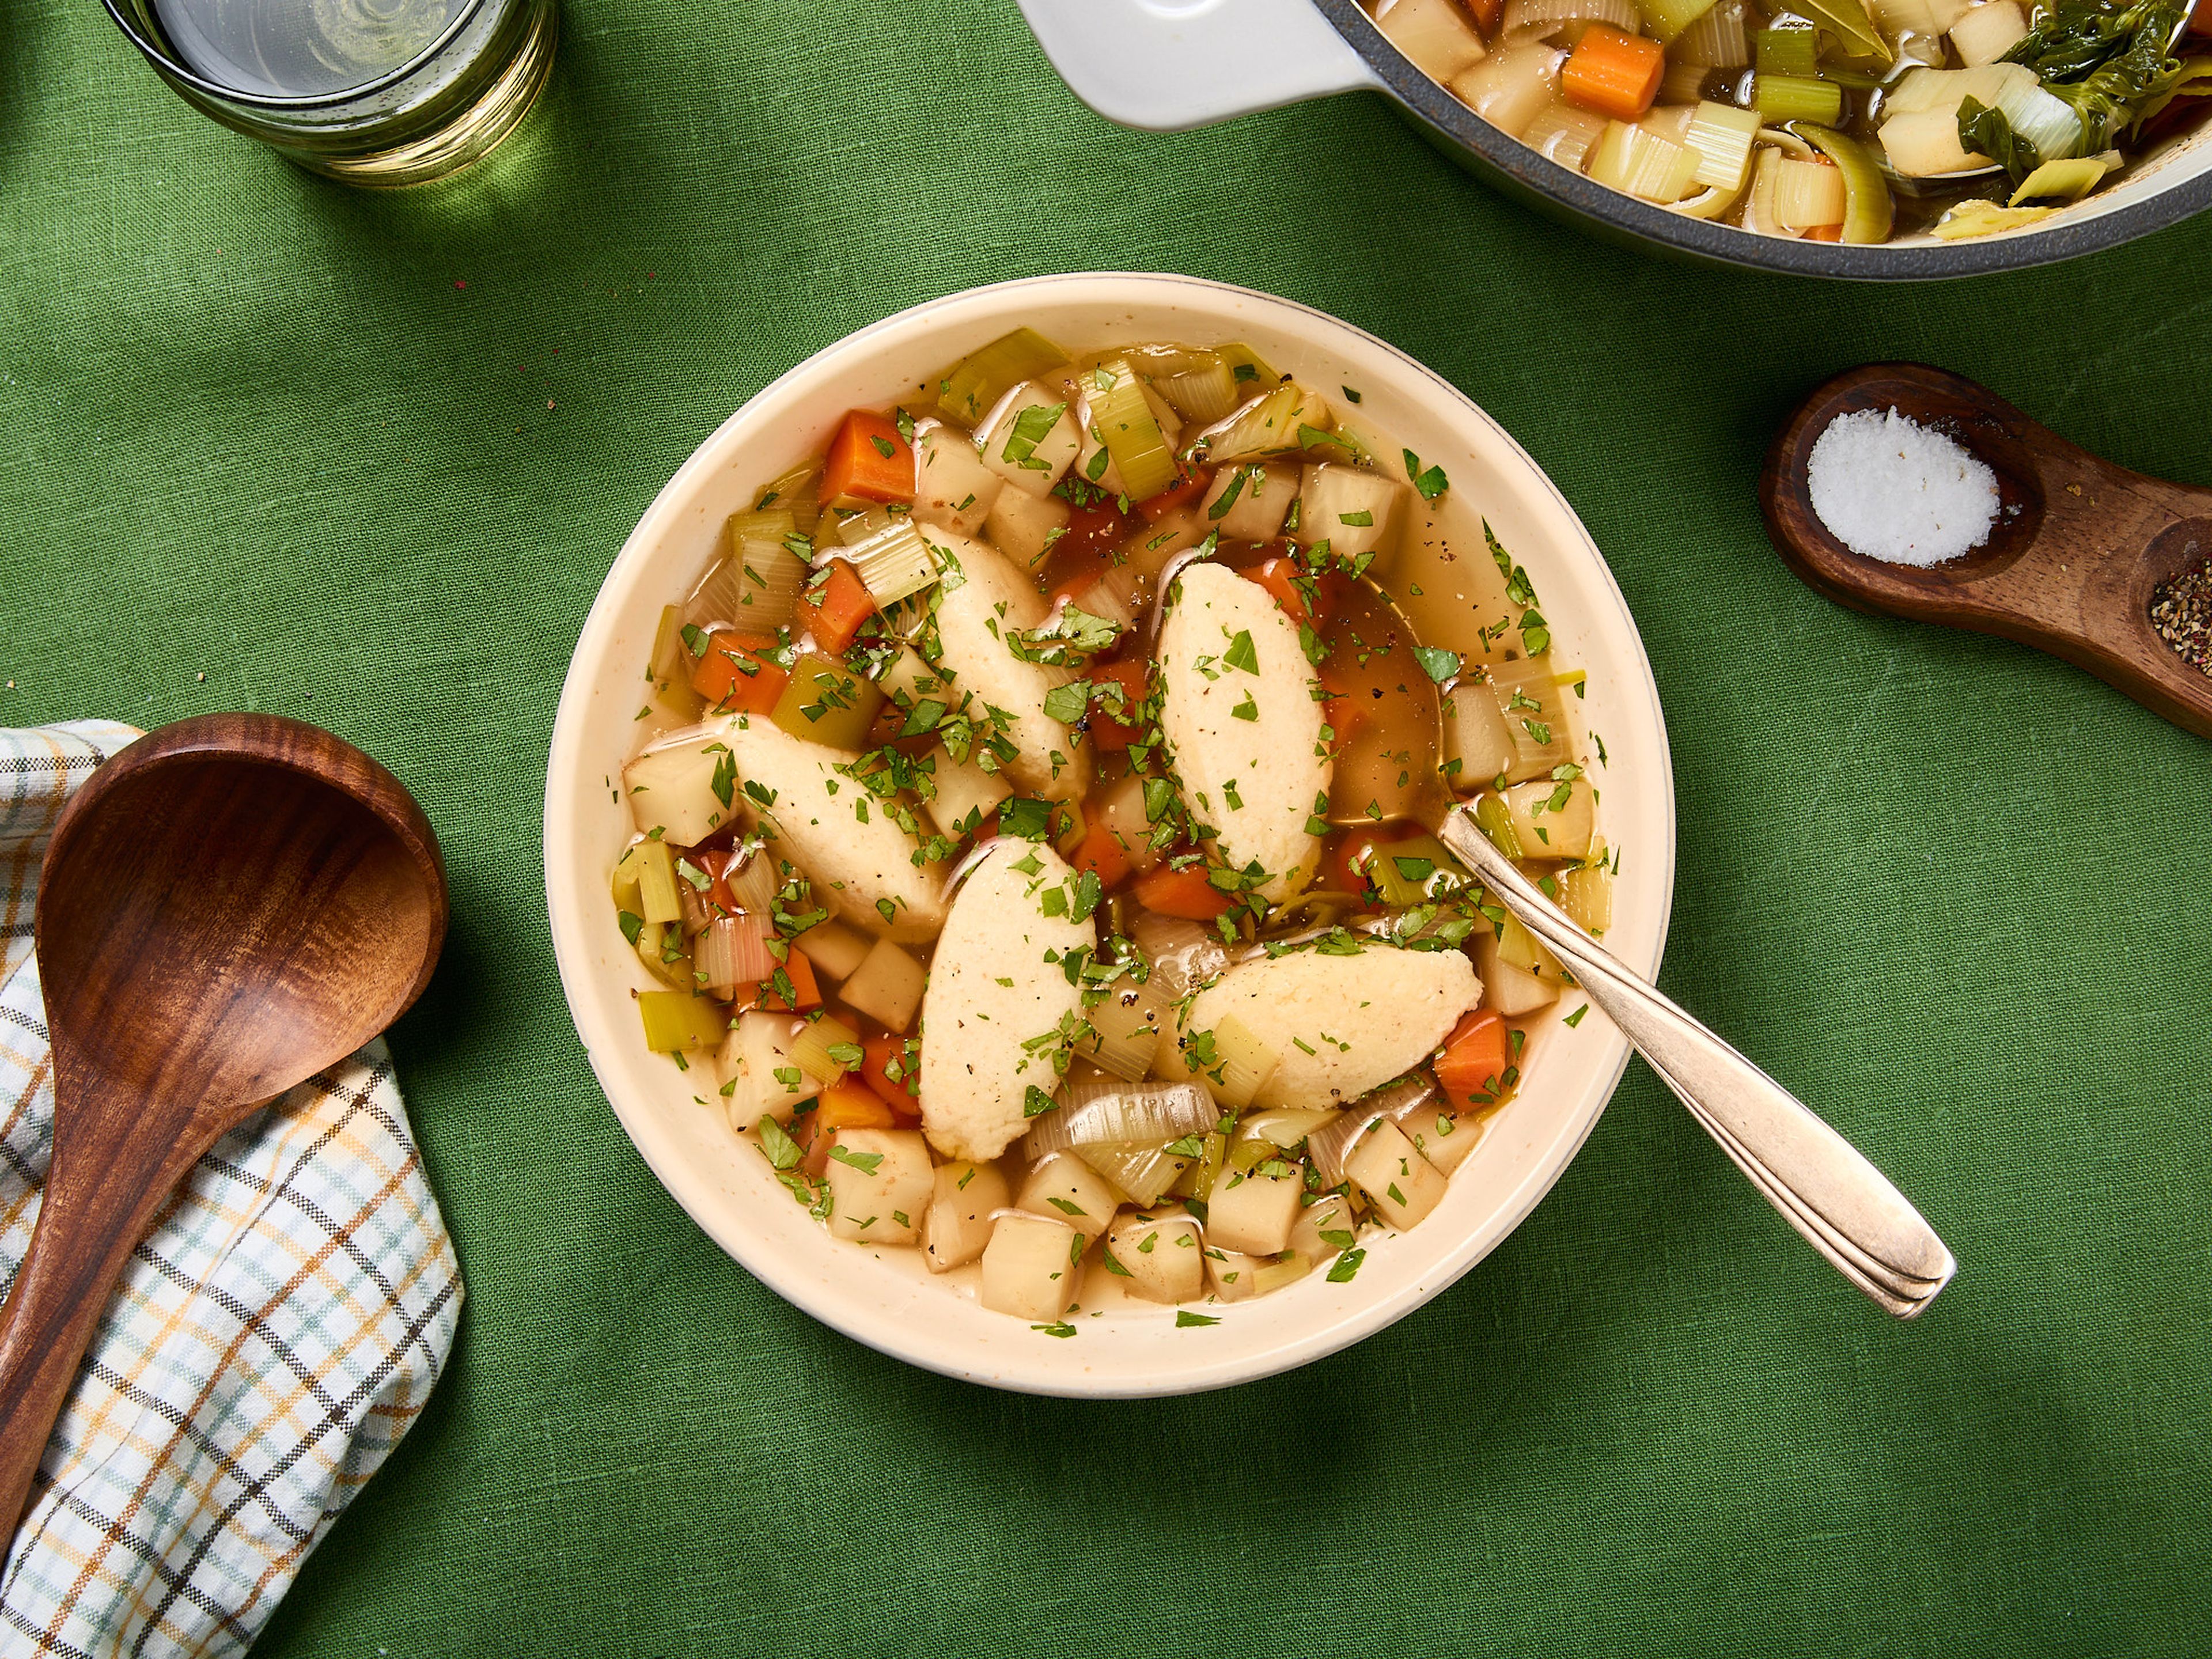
[613,329,1612,1334]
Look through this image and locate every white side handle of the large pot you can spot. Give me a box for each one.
[1020,0,1382,132]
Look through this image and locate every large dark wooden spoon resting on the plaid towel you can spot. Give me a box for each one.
[0,714,447,1537]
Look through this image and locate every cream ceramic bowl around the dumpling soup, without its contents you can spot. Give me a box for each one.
[544,274,1675,1396]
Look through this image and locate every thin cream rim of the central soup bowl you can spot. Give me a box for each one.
[542,272,1679,1398]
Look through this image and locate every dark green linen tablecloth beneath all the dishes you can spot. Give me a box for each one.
[0,0,2212,1659]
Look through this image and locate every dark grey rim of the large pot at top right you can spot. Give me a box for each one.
[1314,0,2212,281]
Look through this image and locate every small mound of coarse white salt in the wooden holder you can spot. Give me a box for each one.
[1807,409,1998,569]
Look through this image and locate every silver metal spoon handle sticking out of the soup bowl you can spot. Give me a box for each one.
[1442,808,1957,1319]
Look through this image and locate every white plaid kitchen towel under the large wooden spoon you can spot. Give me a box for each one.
[0,721,463,1659]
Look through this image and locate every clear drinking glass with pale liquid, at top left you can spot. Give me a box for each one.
[102,0,558,188]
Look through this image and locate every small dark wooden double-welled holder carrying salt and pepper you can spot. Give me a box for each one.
[1759,363,2212,737]
